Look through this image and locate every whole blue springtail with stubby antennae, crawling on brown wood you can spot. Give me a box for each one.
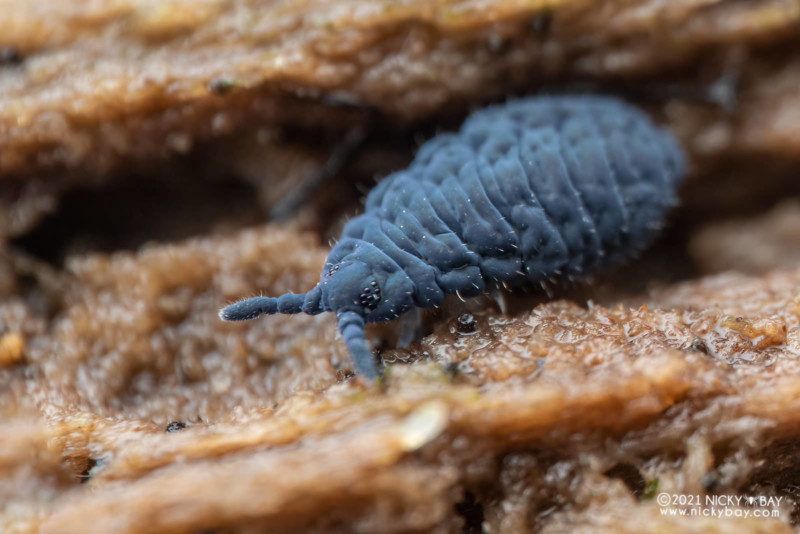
[220,96,684,379]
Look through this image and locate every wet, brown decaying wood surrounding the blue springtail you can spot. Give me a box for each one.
[0,0,800,534]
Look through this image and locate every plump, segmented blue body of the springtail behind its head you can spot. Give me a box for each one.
[345,96,683,291]
